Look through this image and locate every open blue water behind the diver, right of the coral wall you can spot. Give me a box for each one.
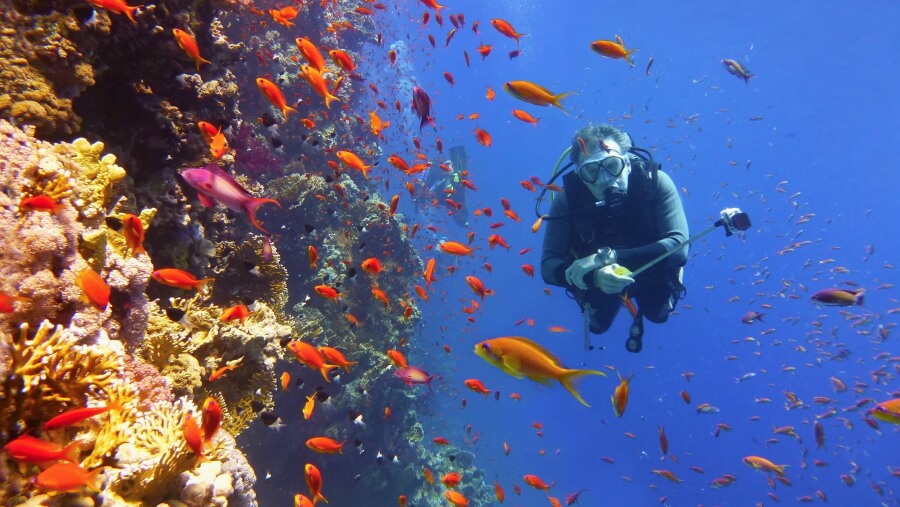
[241,0,900,506]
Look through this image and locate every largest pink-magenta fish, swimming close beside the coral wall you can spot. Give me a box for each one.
[181,164,281,234]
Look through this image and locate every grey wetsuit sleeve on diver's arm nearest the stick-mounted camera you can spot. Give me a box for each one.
[620,171,688,270]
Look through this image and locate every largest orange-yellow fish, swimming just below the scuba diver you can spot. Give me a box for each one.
[475,336,606,407]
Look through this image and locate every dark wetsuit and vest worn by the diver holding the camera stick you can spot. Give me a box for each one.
[541,165,688,334]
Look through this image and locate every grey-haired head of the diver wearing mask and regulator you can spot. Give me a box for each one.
[570,124,631,198]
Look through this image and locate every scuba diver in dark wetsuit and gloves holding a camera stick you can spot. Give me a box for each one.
[538,124,688,352]
